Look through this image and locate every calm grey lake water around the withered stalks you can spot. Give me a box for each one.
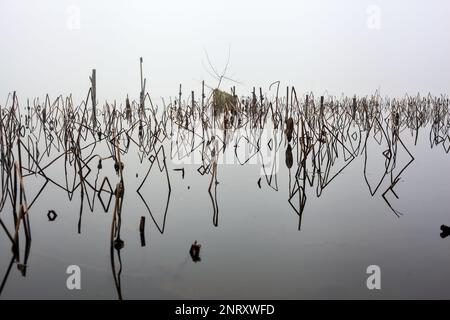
[0,94,450,299]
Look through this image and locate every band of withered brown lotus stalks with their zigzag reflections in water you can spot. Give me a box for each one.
[0,67,450,299]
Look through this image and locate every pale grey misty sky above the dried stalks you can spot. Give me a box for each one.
[0,0,450,105]
